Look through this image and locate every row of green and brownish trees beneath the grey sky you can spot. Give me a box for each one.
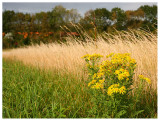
[2,5,157,48]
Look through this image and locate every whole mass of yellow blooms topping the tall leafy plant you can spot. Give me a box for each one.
[82,53,136,96]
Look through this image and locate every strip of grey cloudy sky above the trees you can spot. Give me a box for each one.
[2,2,157,16]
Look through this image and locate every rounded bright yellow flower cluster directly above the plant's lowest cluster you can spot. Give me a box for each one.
[115,68,130,81]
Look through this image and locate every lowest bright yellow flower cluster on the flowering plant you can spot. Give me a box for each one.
[107,84,126,96]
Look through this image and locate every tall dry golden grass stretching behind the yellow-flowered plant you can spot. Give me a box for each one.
[3,31,157,91]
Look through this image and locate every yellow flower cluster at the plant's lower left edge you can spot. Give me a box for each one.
[88,79,105,89]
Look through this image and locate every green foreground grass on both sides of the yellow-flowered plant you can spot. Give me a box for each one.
[2,59,157,118]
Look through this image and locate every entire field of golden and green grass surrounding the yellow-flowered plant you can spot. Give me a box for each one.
[3,31,157,118]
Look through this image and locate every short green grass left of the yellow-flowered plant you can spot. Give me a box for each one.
[3,60,91,118]
